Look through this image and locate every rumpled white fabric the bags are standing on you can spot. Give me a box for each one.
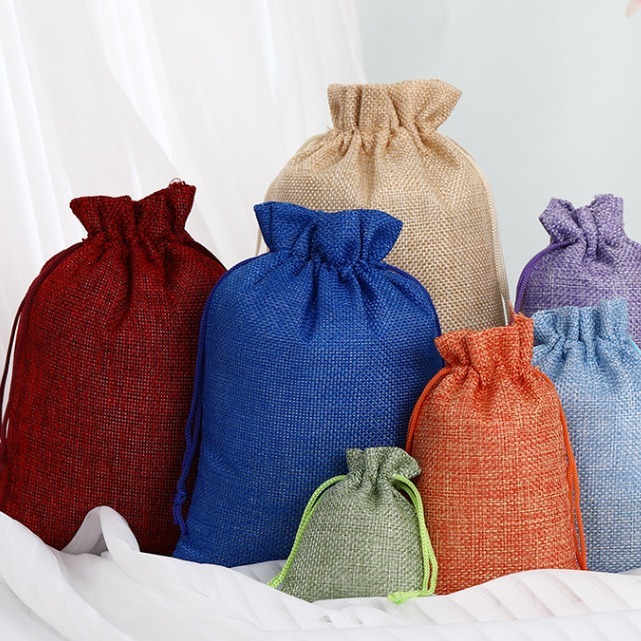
[0,507,641,641]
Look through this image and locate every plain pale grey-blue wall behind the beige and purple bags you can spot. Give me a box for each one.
[356,0,641,294]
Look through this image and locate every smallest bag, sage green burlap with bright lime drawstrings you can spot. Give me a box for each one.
[269,447,437,603]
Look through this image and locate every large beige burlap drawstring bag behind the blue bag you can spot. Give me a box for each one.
[266,80,508,332]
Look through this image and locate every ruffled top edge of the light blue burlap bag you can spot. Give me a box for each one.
[532,299,630,346]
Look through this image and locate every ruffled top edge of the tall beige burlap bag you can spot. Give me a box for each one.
[327,80,460,133]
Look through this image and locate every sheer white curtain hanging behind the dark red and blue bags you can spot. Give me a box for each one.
[0,0,364,350]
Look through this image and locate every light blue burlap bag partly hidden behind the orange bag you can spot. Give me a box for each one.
[533,299,641,572]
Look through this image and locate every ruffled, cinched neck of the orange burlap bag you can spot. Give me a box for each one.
[435,314,534,384]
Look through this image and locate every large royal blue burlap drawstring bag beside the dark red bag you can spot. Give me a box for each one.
[174,202,441,566]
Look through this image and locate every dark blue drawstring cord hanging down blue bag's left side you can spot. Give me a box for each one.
[172,294,211,535]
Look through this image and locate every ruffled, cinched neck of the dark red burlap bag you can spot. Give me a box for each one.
[70,182,196,243]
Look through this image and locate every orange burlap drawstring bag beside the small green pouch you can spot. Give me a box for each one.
[407,315,586,594]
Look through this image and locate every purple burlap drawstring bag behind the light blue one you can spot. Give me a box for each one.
[515,194,641,344]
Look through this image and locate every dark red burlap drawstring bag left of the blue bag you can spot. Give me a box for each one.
[0,183,225,554]
